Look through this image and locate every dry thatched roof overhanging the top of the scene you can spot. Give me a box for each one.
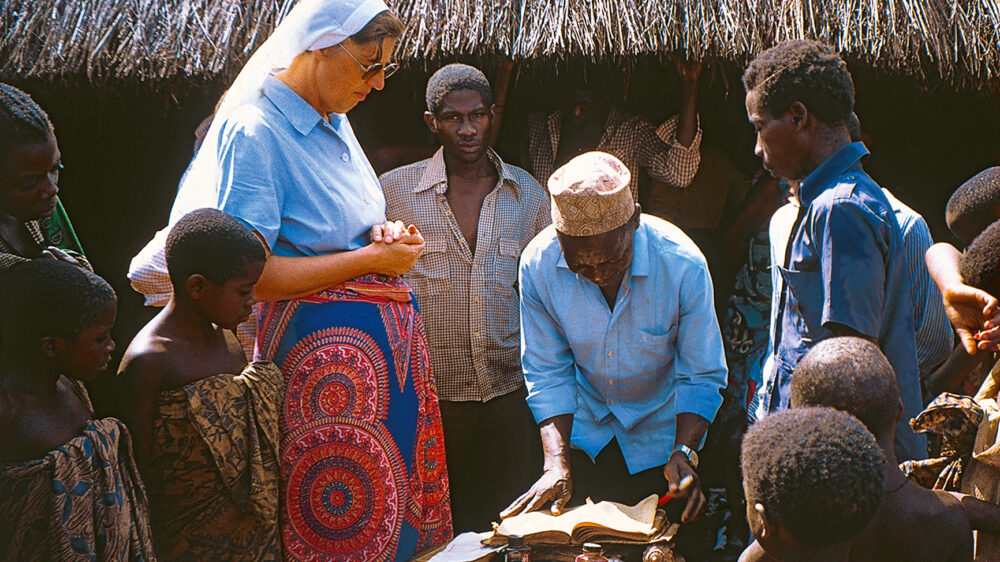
[0,0,1000,88]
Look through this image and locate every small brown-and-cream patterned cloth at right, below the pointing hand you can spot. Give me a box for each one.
[899,392,983,491]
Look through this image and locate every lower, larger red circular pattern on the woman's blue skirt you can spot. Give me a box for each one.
[283,417,405,560]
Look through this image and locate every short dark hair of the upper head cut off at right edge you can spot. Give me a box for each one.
[944,166,1000,244]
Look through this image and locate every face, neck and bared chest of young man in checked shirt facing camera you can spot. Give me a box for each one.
[424,90,499,255]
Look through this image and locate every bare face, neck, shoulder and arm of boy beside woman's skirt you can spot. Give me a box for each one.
[115,262,264,471]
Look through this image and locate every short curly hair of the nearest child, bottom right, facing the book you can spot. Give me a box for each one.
[741,408,885,548]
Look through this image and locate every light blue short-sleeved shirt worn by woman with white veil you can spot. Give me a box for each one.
[217,77,385,256]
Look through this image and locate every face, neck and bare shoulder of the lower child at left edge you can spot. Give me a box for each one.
[0,302,117,463]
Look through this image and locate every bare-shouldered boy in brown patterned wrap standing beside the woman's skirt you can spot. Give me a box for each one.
[116,209,282,560]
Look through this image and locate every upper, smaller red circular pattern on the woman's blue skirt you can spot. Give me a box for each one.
[281,328,389,424]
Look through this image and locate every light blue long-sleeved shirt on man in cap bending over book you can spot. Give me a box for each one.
[519,215,726,474]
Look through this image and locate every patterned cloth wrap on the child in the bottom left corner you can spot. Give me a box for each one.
[0,418,156,562]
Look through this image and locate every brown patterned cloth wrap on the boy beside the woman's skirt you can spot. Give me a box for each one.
[147,362,283,560]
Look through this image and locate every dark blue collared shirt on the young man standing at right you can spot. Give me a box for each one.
[763,142,926,460]
